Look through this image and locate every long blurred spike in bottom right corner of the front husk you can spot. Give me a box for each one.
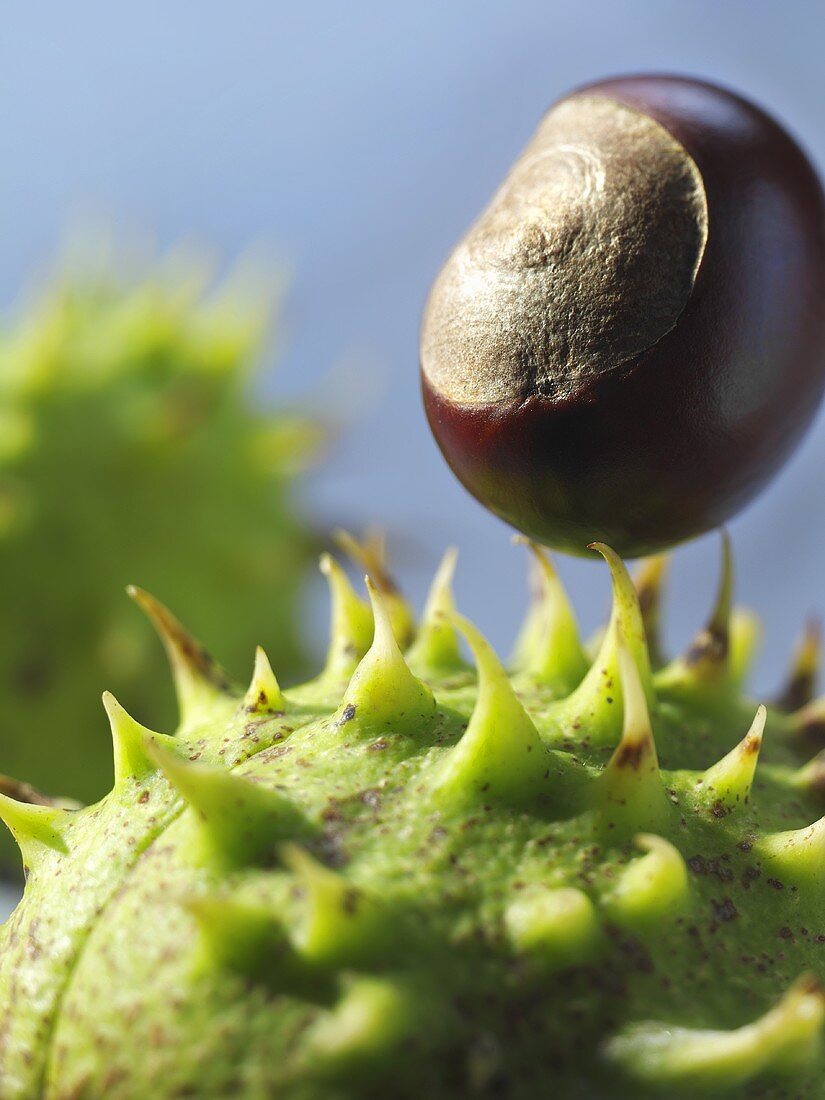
[605,975,825,1096]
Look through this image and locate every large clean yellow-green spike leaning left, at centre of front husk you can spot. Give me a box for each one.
[433,615,558,802]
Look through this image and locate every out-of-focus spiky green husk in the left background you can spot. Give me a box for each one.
[0,259,319,859]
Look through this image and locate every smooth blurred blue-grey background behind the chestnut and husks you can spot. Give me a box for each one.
[0,0,825,910]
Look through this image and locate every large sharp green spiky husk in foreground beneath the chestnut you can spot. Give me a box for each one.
[0,536,825,1100]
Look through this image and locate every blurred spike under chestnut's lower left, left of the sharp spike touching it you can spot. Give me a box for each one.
[514,535,590,697]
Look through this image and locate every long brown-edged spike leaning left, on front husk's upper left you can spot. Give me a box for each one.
[127,584,232,726]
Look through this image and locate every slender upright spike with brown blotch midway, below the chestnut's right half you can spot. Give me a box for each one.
[594,634,669,833]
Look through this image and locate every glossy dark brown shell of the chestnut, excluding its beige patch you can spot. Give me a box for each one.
[422,76,825,557]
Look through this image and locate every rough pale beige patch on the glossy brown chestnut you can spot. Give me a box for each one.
[421,96,708,405]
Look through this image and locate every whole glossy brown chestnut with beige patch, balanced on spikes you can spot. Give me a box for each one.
[421,76,825,557]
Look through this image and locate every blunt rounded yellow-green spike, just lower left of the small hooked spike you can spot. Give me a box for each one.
[504,887,602,969]
